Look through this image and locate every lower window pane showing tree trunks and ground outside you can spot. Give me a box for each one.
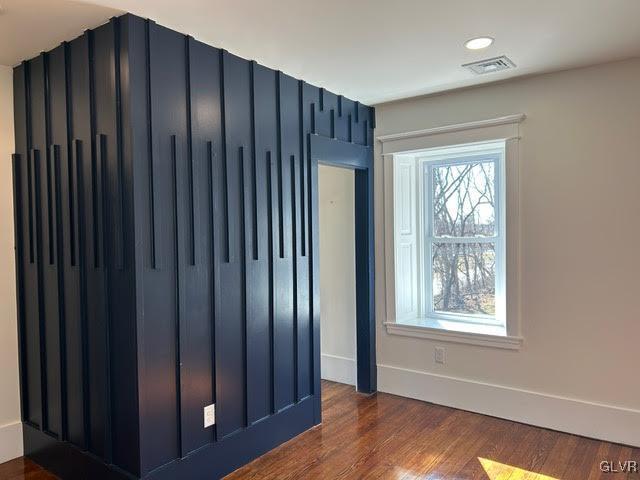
[432,243,496,316]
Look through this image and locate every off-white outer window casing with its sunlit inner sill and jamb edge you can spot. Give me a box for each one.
[376,113,527,350]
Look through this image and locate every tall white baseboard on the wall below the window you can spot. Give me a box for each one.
[378,365,640,447]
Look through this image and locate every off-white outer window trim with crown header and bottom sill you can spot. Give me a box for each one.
[377,114,525,349]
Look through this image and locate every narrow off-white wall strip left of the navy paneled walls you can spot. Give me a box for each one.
[0,66,22,463]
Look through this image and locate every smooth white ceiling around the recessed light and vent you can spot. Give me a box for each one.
[0,0,640,104]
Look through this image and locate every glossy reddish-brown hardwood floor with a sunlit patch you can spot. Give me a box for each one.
[0,381,640,480]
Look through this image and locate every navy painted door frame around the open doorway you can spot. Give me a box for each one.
[307,134,377,422]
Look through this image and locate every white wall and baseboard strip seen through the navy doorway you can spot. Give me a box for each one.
[318,165,356,385]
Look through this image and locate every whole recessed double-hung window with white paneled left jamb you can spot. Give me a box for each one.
[393,141,506,335]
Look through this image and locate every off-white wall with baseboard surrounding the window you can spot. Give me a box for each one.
[375,59,640,445]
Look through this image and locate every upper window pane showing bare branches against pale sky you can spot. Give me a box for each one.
[431,162,496,237]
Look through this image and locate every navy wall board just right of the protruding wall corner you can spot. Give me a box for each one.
[140,19,188,465]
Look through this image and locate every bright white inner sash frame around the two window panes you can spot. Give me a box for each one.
[420,147,506,330]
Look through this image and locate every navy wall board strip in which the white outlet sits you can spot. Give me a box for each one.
[180,38,220,452]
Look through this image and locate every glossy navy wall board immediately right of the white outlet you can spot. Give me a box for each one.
[216,48,252,439]
